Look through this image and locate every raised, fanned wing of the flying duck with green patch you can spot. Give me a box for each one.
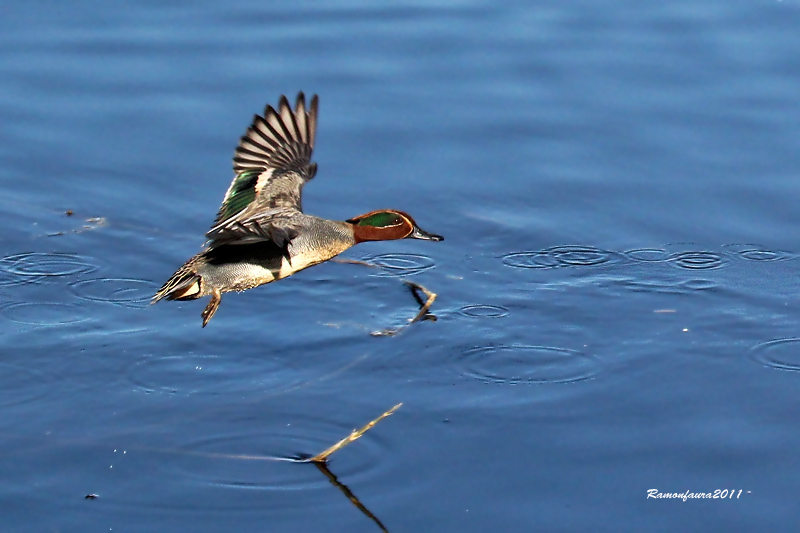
[206,93,319,248]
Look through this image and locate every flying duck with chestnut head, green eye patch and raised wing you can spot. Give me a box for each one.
[153,93,442,327]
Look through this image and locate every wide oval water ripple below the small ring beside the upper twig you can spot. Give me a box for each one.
[457,344,601,385]
